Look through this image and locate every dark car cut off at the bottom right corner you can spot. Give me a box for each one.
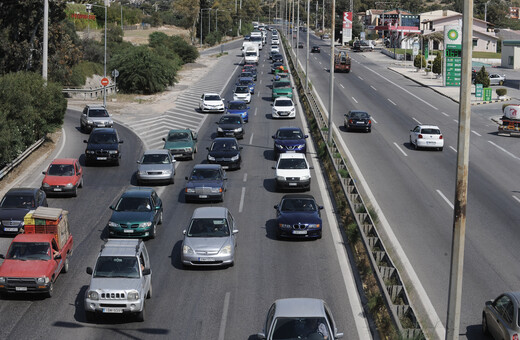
[482,292,520,339]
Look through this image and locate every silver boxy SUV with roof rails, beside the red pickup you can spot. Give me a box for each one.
[85,239,152,322]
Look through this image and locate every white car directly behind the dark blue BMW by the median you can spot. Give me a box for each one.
[273,153,313,191]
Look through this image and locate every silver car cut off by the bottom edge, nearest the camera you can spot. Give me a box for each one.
[257,298,343,340]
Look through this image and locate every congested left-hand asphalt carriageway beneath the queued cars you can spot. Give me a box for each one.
[0,33,366,340]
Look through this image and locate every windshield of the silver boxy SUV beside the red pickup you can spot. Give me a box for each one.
[94,256,140,279]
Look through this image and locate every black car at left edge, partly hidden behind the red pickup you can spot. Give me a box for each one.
[0,188,47,234]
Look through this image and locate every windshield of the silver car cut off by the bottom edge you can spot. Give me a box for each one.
[271,317,331,340]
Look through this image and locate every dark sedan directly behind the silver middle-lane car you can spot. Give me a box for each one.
[184,164,227,202]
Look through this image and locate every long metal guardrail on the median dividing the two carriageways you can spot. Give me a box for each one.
[283,34,425,339]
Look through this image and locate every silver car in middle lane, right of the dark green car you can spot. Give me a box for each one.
[181,207,238,267]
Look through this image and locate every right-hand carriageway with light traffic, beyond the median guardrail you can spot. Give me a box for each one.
[295,28,520,339]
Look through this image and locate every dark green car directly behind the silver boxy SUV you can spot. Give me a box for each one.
[108,187,163,238]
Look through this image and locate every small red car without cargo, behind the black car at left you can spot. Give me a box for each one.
[42,158,83,197]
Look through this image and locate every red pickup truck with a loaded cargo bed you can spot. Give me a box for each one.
[0,207,74,297]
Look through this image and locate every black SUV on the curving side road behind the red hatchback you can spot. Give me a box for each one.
[83,128,123,165]
